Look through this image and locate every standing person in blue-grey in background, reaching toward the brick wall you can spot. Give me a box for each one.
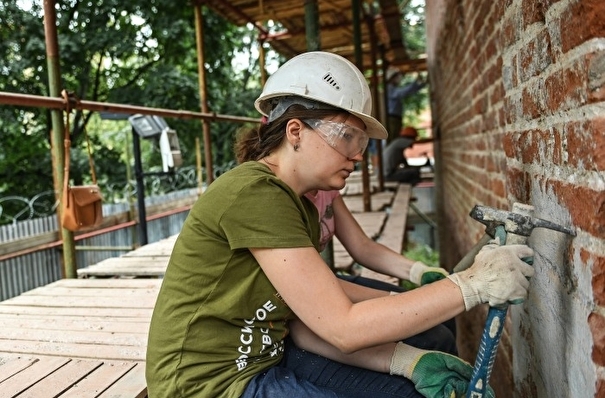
[386,67,426,145]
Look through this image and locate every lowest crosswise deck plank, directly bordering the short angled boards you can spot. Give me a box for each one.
[0,340,146,360]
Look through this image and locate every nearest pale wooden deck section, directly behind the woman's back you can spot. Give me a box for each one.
[0,279,161,398]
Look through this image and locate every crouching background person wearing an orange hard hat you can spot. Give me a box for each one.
[382,126,431,185]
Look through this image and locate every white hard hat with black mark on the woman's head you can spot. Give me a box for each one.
[254,51,388,139]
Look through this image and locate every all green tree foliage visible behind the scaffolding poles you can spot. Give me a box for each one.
[0,0,426,208]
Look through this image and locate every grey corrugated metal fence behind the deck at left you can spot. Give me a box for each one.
[0,188,199,300]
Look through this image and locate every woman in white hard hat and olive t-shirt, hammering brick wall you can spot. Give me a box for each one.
[146,52,533,398]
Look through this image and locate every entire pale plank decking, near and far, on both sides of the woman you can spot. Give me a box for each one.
[0,182,409,398]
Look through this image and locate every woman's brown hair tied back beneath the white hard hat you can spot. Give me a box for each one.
[234,104,348,163]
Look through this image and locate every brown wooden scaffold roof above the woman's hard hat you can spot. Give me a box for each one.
[200,0,422,69]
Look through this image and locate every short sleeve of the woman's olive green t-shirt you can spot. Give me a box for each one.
[220,179,319,250]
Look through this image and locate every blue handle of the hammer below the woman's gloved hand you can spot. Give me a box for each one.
[466,305,508,398]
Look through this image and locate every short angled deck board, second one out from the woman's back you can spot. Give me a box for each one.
[61,362,139,398]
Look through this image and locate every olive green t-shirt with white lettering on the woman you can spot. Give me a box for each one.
[146,162,319,398]
